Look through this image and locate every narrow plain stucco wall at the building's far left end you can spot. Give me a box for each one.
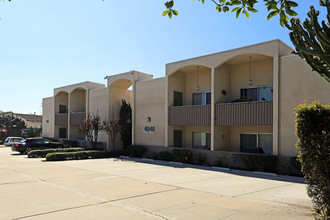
[42,97,55,137]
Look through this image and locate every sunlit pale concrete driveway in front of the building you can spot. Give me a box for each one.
[0,148,313,219]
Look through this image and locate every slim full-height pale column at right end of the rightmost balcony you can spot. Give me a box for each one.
[273,51,280,155]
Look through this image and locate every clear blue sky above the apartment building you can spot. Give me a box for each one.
[0,0,325,114]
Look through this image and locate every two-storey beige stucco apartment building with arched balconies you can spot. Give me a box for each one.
[43,40,330,156]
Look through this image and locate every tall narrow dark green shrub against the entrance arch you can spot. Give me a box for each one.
[119,99,132,149]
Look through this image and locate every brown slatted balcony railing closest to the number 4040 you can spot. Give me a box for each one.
[168,105,211,126]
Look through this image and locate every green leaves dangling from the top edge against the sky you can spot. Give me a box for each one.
[163,0,298,27]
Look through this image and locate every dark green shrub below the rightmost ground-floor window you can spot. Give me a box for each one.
[233,154,278,172]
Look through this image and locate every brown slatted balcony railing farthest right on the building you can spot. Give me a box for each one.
[215,101,273,126]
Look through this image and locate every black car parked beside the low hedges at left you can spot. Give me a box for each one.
[11,138,63,154]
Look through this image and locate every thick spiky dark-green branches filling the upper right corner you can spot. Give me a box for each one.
[285,0,330,82]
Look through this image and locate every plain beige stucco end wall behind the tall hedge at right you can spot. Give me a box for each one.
[279,55,330,156]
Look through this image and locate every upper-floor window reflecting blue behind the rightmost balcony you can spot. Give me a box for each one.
[241,86,273,101]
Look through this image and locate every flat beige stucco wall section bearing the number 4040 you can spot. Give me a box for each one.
[134,78,166,146]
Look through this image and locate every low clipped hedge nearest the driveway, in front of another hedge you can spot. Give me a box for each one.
[46,150,112,161]
